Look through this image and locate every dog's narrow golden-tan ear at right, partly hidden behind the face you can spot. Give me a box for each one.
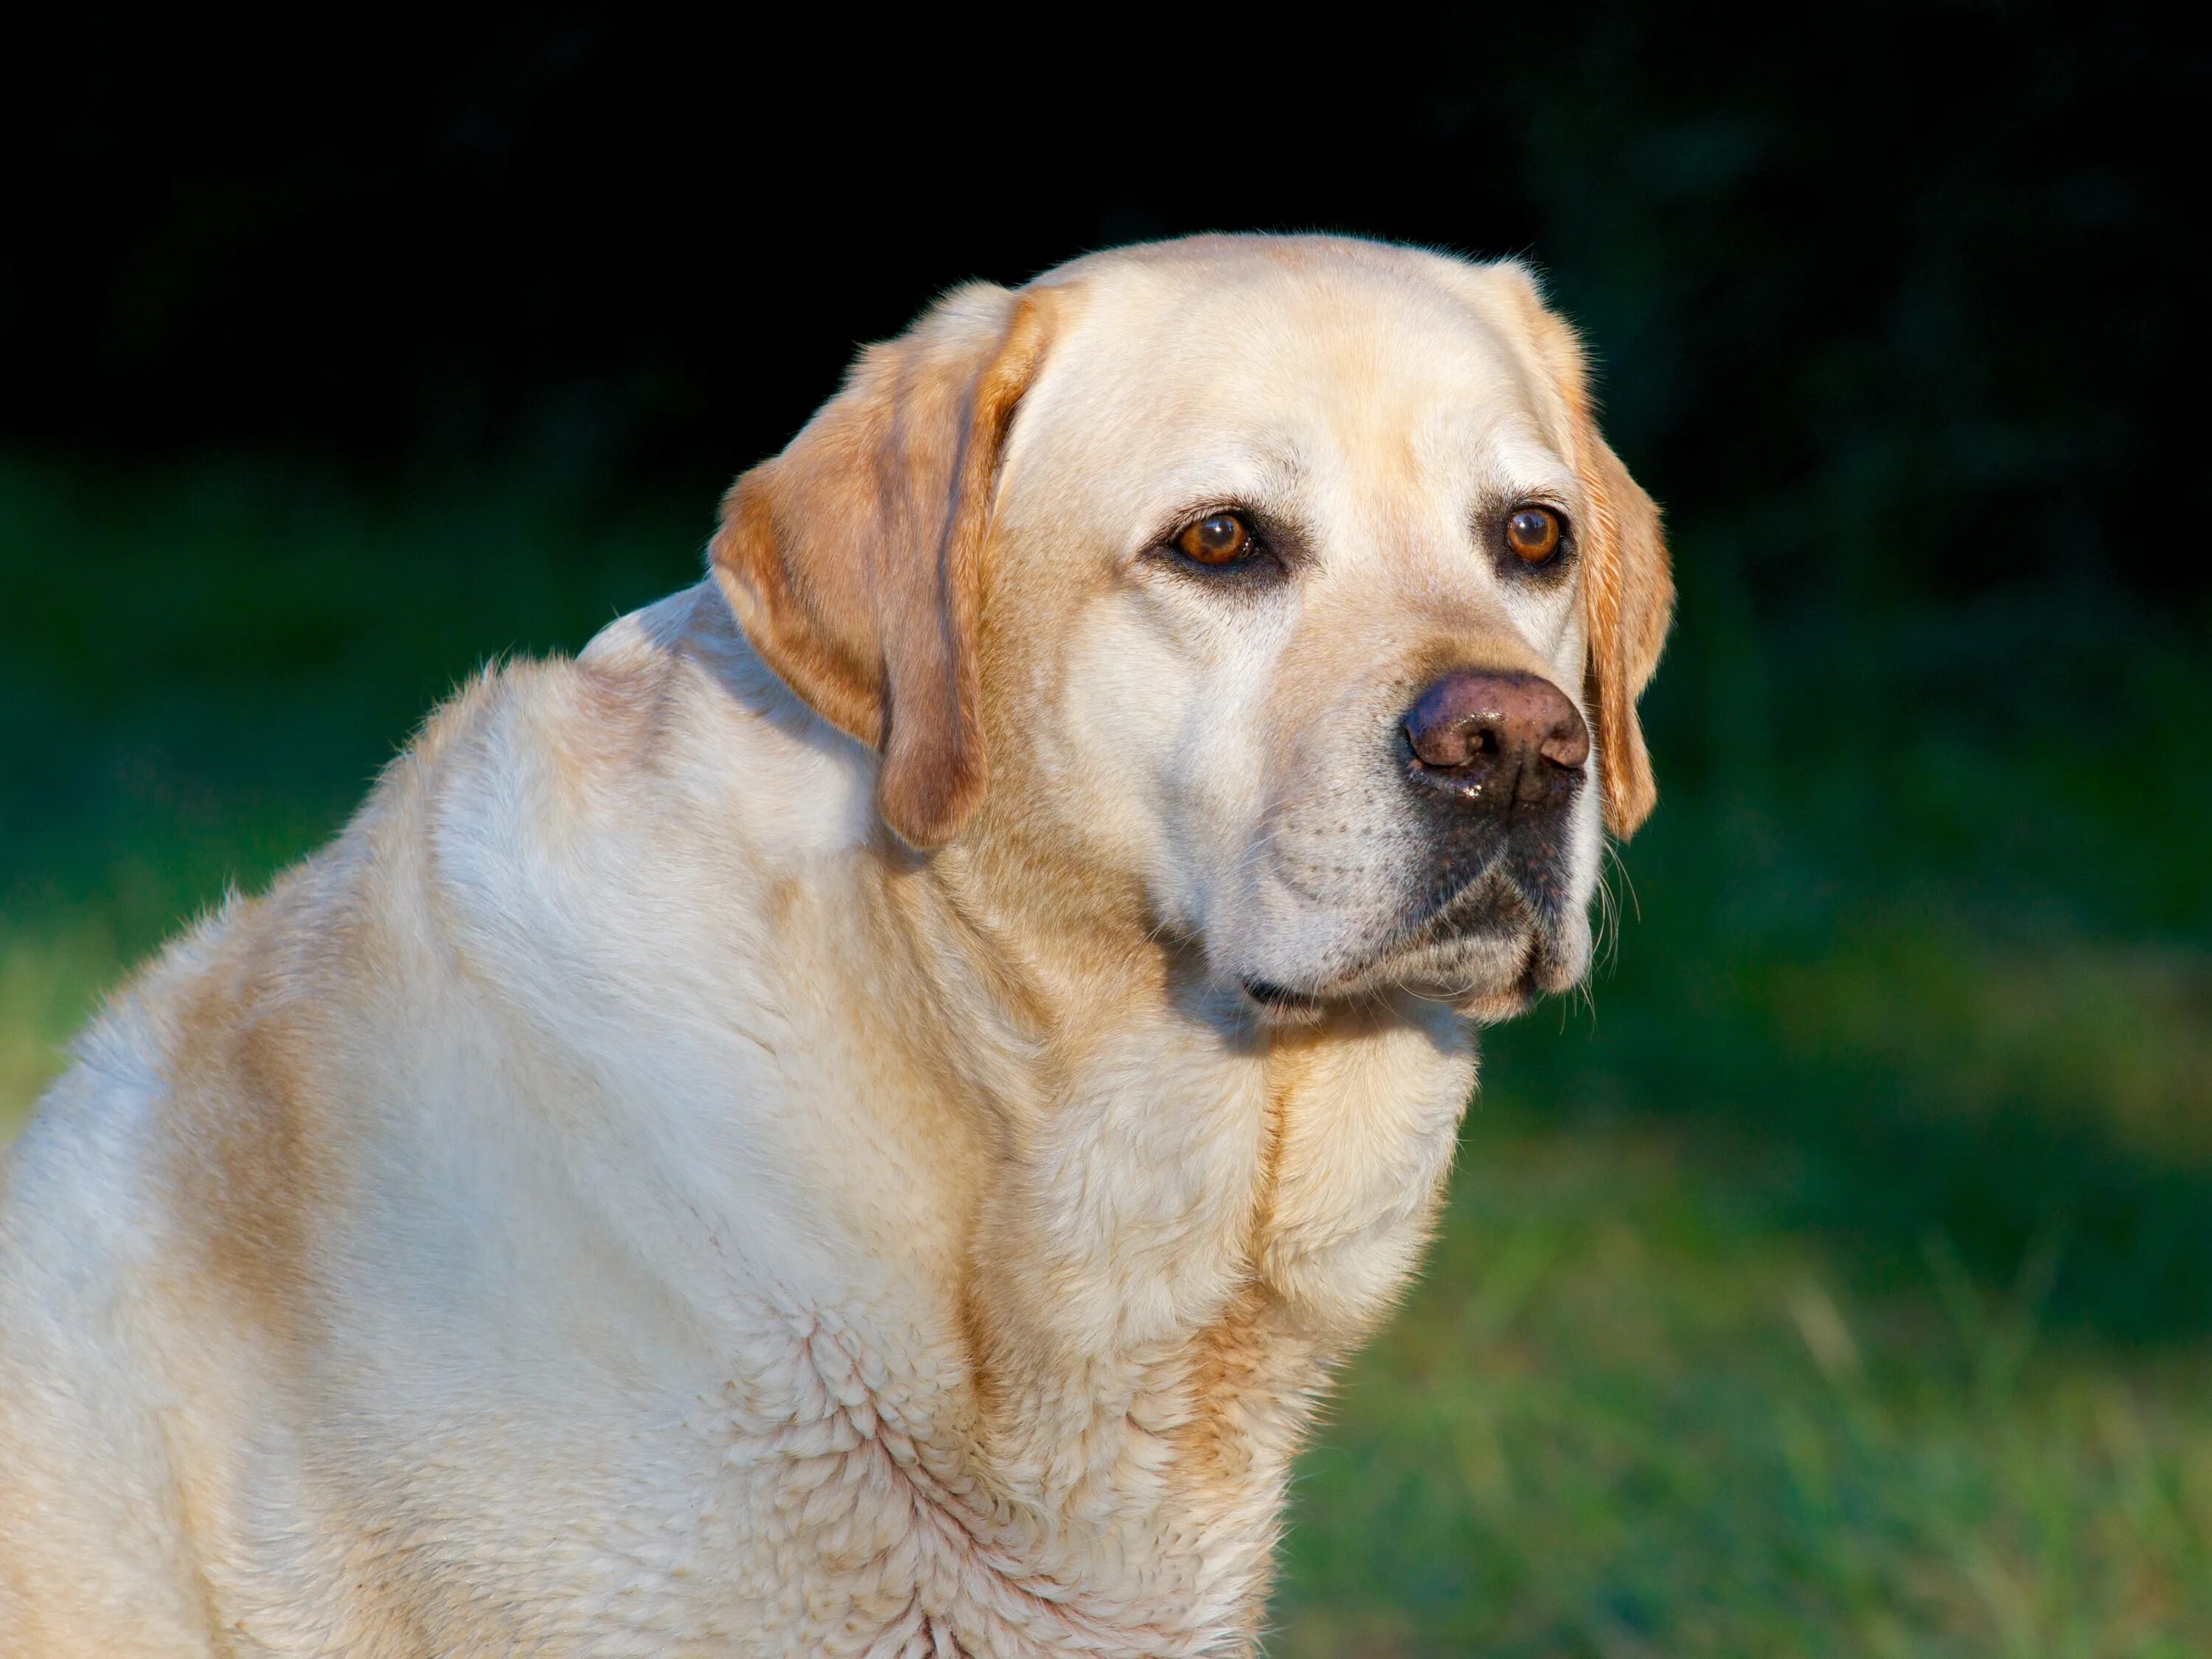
[1493,261,1674,841]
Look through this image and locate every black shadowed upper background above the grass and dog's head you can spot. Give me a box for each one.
[0,2,2212,597]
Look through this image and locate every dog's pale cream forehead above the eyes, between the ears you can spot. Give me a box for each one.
[1018,237,1559,487]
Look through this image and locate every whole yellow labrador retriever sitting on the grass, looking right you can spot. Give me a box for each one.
[0,237,1672,1659]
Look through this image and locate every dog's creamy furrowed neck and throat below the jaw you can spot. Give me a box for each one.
[858,841,1473,1637]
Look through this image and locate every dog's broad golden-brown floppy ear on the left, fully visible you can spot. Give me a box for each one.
[710,283,1048,849]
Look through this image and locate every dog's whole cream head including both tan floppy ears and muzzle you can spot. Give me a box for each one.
[712,237,1672,1018]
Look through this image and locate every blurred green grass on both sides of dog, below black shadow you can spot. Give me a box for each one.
[0,458,2212,1659]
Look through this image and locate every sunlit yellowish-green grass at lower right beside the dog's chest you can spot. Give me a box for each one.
[1274,1110,2212,1659]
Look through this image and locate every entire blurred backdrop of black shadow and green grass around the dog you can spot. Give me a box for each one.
[0,0,2212,1659]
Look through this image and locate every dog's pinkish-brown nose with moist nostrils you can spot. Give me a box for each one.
[1405,668,1590,812]
